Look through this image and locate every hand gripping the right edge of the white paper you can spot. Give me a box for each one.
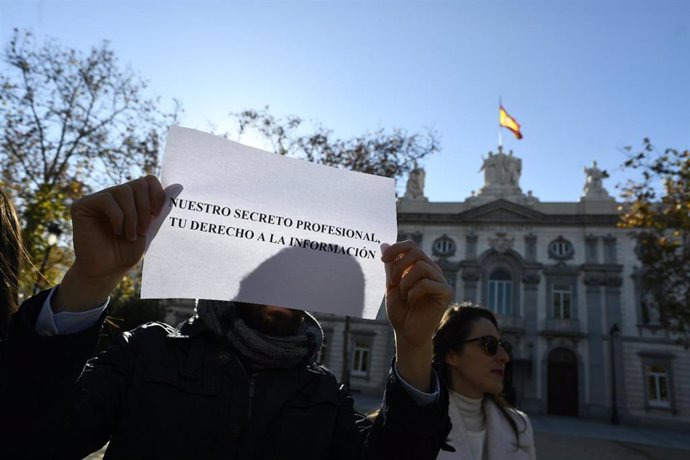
[381,241,453,347]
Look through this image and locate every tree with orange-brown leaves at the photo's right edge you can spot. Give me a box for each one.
[620,139,690,343]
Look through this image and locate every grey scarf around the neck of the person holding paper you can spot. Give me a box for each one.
[196,300,323,369]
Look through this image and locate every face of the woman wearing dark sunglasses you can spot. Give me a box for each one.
[445,318,510,399]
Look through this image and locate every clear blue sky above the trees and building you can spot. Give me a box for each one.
[0,0,690,201]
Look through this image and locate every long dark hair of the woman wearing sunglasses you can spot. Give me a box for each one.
[434,302,527,448]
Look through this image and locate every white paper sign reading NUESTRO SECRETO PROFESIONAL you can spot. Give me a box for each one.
[141,127,397,318]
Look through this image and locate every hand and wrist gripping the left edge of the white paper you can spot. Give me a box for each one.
[53,176,165,312]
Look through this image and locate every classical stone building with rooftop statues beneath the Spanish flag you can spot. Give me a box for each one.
[320,148,690,425]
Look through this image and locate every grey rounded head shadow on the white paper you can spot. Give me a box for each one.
[235,247,365,316]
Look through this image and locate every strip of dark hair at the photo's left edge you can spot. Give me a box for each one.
[0,190,24,338]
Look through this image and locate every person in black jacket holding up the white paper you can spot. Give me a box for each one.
[9,176,452,460]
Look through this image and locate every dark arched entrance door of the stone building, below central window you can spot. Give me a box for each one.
[546,348,578,417]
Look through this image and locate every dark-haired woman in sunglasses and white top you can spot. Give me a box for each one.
[434,304,536,460]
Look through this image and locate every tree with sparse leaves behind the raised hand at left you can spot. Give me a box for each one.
[0,30,179,292]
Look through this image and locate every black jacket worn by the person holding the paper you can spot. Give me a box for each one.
[6,296,448,460]
